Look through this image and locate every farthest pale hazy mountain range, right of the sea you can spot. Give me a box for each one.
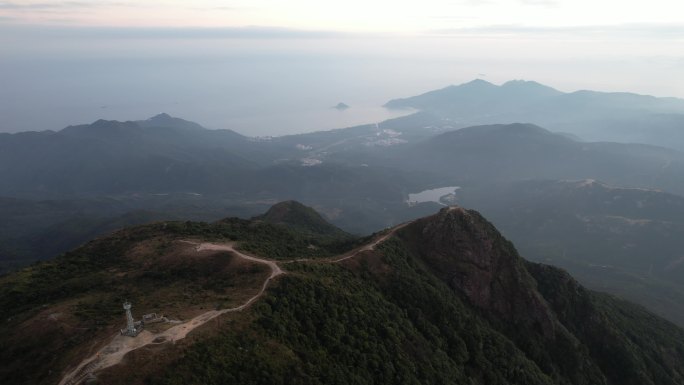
[385,79,684,150]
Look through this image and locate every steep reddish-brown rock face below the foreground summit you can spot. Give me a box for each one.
[404,207,558,338]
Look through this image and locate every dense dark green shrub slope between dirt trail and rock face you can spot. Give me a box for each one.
[157,243,552,384]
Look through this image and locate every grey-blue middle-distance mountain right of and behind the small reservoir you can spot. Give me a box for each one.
[387,123,684,193]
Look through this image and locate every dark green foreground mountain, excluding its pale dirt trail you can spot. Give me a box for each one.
[0,202,684,385]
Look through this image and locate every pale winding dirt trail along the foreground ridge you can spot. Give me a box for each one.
[59,223,408,385]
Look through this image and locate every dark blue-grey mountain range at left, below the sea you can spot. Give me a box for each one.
[0,115,259,196]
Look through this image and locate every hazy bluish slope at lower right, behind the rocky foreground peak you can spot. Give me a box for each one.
[459,181,684,326]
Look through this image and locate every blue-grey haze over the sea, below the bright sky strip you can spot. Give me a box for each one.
[0,28,680,136]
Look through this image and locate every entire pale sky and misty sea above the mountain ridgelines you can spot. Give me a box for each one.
[0,0,684,135]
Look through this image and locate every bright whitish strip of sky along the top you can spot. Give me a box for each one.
[0,0,682,33]
